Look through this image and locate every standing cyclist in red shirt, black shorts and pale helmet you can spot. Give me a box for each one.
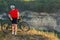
[8,5,19,35]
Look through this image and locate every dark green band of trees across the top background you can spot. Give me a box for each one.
[0,0,60,13]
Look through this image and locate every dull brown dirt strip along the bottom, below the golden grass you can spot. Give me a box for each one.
[5,34,48,40]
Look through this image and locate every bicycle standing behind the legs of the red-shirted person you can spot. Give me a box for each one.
[2,16,30,32]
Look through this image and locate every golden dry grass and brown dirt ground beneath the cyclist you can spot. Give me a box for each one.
[1,30,58,40]
